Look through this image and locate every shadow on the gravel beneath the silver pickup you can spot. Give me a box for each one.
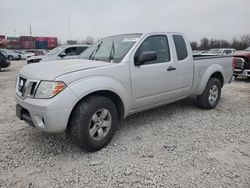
[25,98,200,158]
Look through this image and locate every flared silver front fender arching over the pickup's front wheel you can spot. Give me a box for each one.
[68,76,131,116]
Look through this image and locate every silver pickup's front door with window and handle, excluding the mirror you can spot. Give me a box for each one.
[130,35,176,110]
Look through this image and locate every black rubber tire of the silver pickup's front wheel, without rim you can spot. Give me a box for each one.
[67,95,118,151]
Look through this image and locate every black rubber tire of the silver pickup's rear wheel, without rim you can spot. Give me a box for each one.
[197,78,222,109]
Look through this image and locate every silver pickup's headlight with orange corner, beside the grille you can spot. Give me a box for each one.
[35,81,66,99]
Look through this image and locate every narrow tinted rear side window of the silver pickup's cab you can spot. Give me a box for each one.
[173,35,188,61]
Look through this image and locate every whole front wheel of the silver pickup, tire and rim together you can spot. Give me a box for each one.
[68,96,118,151]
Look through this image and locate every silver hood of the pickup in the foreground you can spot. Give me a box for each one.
[19,59,112,80]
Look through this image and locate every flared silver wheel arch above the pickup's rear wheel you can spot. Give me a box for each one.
[198,64,224,95]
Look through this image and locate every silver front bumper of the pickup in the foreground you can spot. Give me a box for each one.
[16,88,78,133]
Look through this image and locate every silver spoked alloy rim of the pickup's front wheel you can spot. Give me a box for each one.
[89,108,112,141]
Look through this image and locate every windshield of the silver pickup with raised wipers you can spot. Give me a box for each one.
[80,34,141,63]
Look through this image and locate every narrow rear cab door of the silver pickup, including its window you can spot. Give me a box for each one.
[173,35,194,97]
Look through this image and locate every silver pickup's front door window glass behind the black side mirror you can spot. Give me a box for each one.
[134,35,170,64]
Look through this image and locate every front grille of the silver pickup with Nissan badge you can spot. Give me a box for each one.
[16,76,38,98]
